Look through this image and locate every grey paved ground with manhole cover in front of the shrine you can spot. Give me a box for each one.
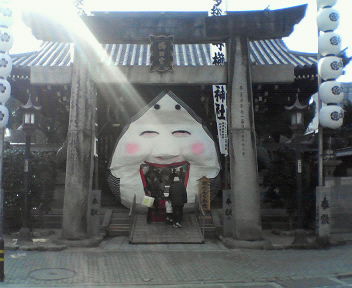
[0,237,352,288]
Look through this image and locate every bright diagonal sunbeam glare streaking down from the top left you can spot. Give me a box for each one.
[15,0,145,112]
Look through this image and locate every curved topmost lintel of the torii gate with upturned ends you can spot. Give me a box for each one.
[24,5,307,44]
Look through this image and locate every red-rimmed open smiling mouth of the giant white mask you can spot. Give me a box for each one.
[139,157,191,194]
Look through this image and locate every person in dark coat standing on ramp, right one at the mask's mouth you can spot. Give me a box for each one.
[170,176,187,228]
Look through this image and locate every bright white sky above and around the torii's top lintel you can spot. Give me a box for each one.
[10,0,352,82]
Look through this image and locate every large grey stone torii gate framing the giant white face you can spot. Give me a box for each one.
[25,5,306,241]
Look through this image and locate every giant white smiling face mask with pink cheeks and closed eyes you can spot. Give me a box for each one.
[110,91,220,207]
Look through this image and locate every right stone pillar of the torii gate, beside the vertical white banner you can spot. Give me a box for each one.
[228,36,262,241]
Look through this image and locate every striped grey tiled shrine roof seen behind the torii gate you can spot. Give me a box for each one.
[11,39,317,67]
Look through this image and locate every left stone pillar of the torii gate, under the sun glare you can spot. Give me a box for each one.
[62,49,97,240]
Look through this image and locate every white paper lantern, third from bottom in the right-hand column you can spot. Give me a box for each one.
[318,56,343,80]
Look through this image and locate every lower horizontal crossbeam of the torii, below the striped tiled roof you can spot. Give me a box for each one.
[30,64,295,85]
